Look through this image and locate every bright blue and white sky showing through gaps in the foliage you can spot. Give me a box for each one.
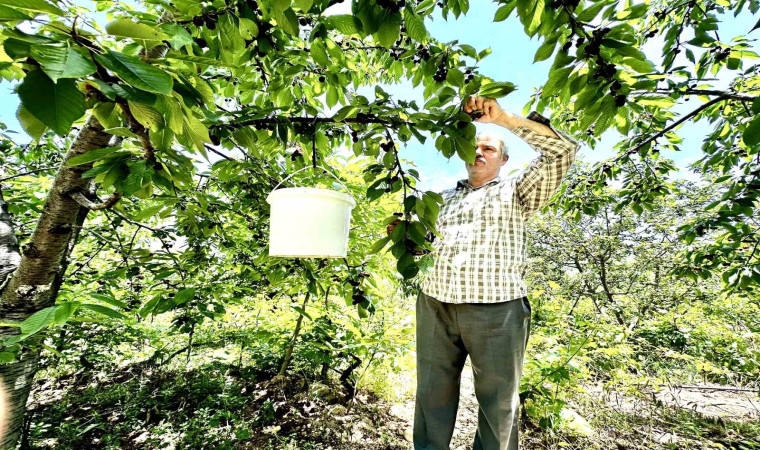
[0,0,759,191]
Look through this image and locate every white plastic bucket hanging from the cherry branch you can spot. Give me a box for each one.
[267,167,356,258]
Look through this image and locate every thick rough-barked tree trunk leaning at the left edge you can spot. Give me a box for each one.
[0,117,111,449]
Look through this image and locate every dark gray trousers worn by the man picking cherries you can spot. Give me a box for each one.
[413,291,531,450]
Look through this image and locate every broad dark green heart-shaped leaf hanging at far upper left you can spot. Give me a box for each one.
[18,70,86,136]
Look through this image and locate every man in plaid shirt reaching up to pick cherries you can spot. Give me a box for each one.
[413,97,578,450]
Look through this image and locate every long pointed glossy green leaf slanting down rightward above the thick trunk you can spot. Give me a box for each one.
[95,50,173,95]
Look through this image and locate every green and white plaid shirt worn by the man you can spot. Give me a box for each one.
[420,112,580,303]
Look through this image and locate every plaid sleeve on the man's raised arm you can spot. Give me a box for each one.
[512,112,580,218]
